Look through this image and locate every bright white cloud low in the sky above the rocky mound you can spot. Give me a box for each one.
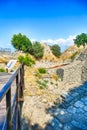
[41,36,75,50]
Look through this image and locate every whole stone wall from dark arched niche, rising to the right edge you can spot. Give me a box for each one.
[56,48,87,84]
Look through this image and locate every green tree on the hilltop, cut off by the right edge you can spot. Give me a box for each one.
[74,33,87,47]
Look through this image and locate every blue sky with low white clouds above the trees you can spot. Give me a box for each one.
[0,0,87,51]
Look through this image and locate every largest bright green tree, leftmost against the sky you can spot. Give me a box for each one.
[11,33,32,53]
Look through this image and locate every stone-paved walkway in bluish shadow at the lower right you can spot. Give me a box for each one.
[45,82,87,130]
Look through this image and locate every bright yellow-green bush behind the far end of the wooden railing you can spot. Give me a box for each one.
[18,55,35,66]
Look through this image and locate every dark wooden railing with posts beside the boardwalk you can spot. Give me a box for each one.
[0,64,24,130]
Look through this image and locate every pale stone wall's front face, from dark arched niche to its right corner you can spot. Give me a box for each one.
[56,61,84,84]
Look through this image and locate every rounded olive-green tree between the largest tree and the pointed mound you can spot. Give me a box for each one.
[32,41,44,59]
